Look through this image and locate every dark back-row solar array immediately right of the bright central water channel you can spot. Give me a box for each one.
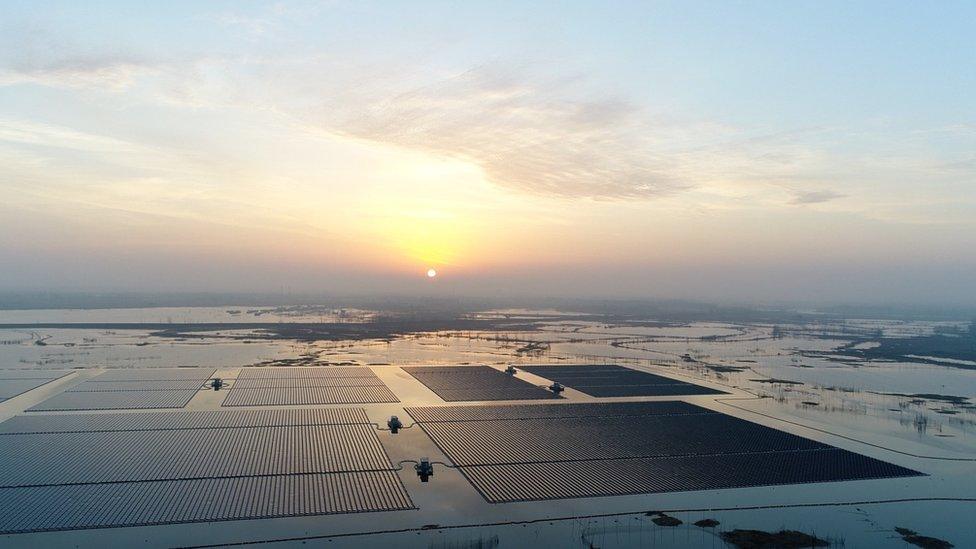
[403,366,556,402]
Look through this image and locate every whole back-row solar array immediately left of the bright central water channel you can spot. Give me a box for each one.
[222,367,400,406]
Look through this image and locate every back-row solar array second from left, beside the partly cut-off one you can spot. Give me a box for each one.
[28,368,214,412]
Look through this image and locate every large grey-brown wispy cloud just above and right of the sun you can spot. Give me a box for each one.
[327,67,691,199]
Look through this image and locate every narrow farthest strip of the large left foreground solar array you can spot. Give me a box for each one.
[0,408,369,435]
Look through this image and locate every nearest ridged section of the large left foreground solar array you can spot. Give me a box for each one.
[0,471,413,533]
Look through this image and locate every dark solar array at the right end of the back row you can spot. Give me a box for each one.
[521,364,725,397]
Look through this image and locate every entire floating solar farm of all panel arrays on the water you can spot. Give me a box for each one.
[0,365,921,534]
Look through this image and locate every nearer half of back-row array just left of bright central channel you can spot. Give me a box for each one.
[221,385,400,406]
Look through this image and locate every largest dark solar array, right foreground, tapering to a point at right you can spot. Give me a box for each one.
[407,402,920,503]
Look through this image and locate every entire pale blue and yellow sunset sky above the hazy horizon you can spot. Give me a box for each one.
[0,0,976,305]
